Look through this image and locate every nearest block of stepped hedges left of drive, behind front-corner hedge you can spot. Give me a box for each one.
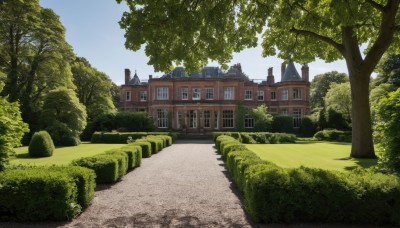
[72,155,119,184]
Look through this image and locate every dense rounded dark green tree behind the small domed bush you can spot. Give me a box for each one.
[41,87,87,146]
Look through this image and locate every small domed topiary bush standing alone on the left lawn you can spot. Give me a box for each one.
[29,131,55,158]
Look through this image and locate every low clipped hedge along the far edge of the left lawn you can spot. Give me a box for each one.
[91,132,177,145]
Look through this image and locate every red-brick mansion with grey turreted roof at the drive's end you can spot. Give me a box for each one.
[120,61,310,133]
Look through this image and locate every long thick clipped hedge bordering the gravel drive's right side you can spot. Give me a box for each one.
[216,136,400,225]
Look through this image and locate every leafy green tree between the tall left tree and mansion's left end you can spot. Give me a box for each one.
[71,57,115,121]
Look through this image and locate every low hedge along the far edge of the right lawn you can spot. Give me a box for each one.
[213,132,297,144]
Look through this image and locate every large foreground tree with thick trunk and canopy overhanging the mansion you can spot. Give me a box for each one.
[117,0,400,158]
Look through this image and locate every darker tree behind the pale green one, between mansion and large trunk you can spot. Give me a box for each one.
[310,71,349,109]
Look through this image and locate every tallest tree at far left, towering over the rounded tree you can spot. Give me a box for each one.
[0,0,74,134]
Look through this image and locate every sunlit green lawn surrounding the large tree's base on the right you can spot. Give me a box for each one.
[246,142,377,170]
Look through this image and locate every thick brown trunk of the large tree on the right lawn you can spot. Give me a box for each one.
[349,71,376,158]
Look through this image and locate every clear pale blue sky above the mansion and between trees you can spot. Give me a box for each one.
[40,0,347,85]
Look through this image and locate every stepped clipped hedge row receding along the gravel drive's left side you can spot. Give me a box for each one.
[72,135,172,184]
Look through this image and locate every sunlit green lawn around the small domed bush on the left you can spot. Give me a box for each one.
[10,142,124,165]
